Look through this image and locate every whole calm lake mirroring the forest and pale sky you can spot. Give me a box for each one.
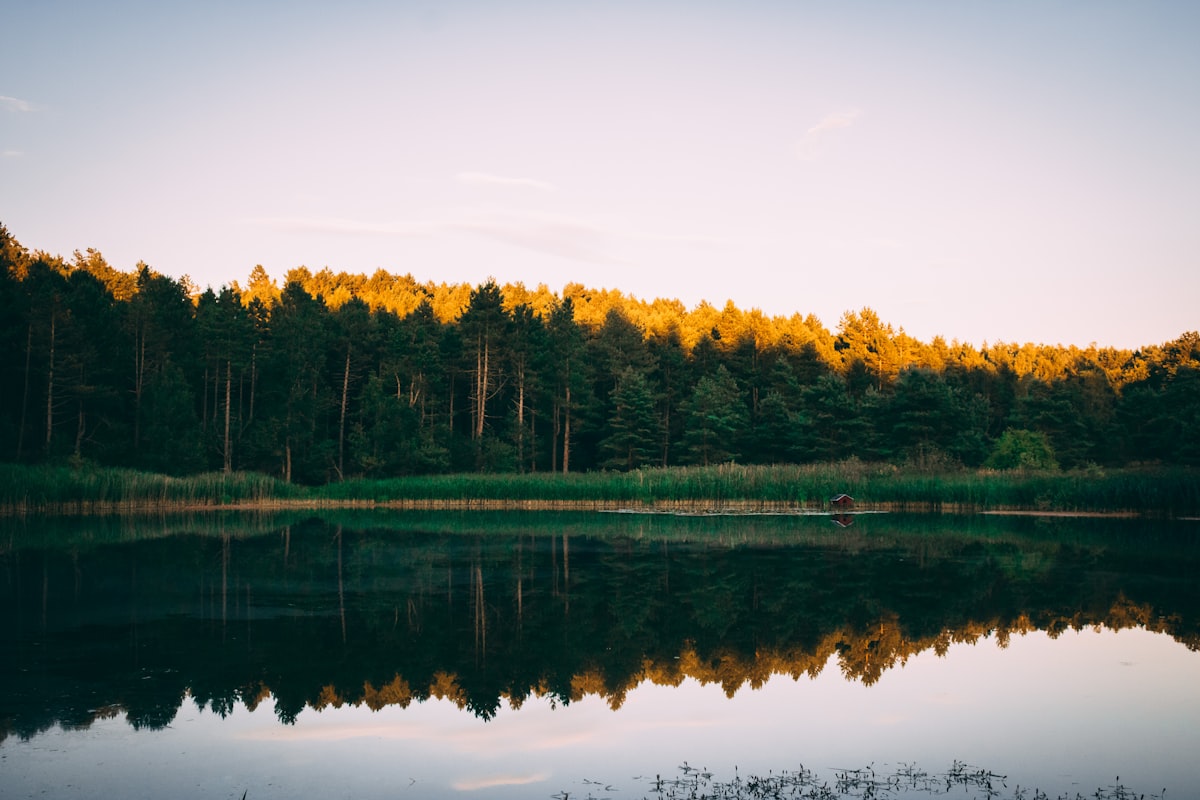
[0,511,1200,800]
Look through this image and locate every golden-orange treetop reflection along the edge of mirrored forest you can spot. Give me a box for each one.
[302,597,1200,711]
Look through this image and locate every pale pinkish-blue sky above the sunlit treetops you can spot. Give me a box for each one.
[0,0,1200,348]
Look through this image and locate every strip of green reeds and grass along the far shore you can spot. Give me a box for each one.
[0,459,1200,517]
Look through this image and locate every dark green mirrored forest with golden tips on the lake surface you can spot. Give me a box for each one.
[0,517,1200,735]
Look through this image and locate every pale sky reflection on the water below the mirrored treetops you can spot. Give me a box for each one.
[0,630,1200,800]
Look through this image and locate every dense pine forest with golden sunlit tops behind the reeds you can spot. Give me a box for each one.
[0,219,1200,483]
